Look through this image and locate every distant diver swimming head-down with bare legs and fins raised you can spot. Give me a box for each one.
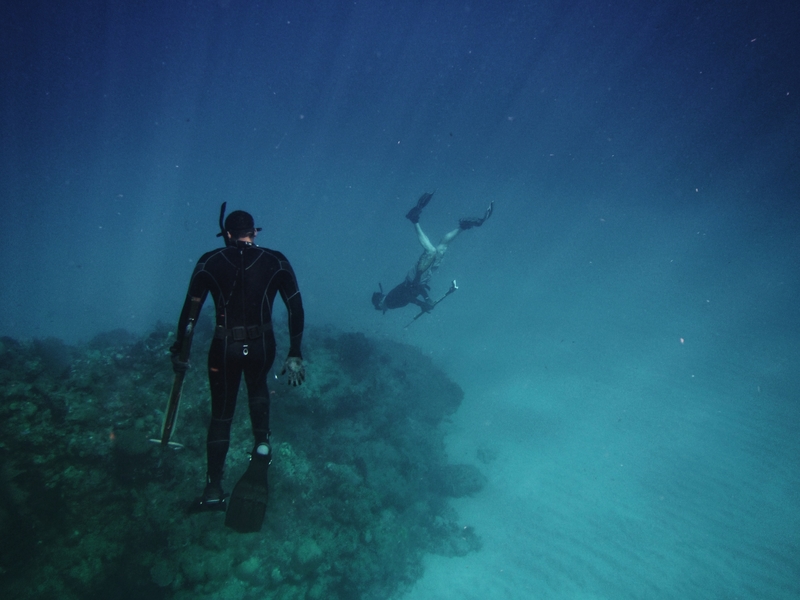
[372,193,494,313]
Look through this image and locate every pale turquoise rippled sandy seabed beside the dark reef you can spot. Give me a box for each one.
[406,336,800,600]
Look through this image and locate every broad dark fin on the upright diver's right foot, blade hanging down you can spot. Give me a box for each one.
[225,452,271,533]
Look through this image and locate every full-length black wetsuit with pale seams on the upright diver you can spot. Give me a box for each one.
[173,241,304,483]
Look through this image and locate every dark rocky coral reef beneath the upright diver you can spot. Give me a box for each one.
[0,323,484,600]
